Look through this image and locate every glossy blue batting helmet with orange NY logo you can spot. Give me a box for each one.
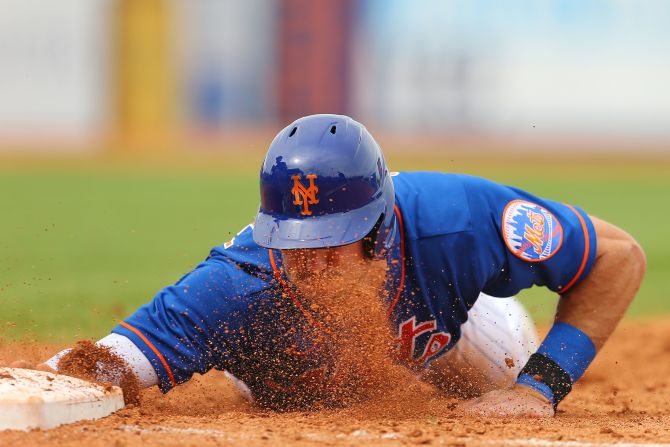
[253,115,395,254]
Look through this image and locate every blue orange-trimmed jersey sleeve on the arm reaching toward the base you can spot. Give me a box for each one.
[112,251,270,392]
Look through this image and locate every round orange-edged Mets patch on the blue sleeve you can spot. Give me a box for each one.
[502,200,563,262]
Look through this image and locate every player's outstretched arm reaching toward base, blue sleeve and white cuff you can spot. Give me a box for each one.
[14,226,271,392]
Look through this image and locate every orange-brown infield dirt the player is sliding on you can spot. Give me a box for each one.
[0,318,670,447]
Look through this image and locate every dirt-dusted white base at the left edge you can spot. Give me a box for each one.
[0,368,124,430]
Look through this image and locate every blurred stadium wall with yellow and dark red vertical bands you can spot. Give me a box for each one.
[0,0,670,152]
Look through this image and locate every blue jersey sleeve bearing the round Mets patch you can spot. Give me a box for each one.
[465,177,596,297]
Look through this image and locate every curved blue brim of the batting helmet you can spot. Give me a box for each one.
[253,200,384,250]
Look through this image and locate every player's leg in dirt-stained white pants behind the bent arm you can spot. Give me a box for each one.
[423,294,538,397]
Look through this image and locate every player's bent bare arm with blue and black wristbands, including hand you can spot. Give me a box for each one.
[463,217,646,416]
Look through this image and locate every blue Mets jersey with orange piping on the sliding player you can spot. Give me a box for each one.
[113,172,596,412]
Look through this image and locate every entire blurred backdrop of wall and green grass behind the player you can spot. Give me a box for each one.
[0,0,670,340]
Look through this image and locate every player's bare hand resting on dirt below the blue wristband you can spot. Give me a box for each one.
[458,385,554,417]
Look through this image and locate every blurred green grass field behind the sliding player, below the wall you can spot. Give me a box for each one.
[0,155,670,341]
